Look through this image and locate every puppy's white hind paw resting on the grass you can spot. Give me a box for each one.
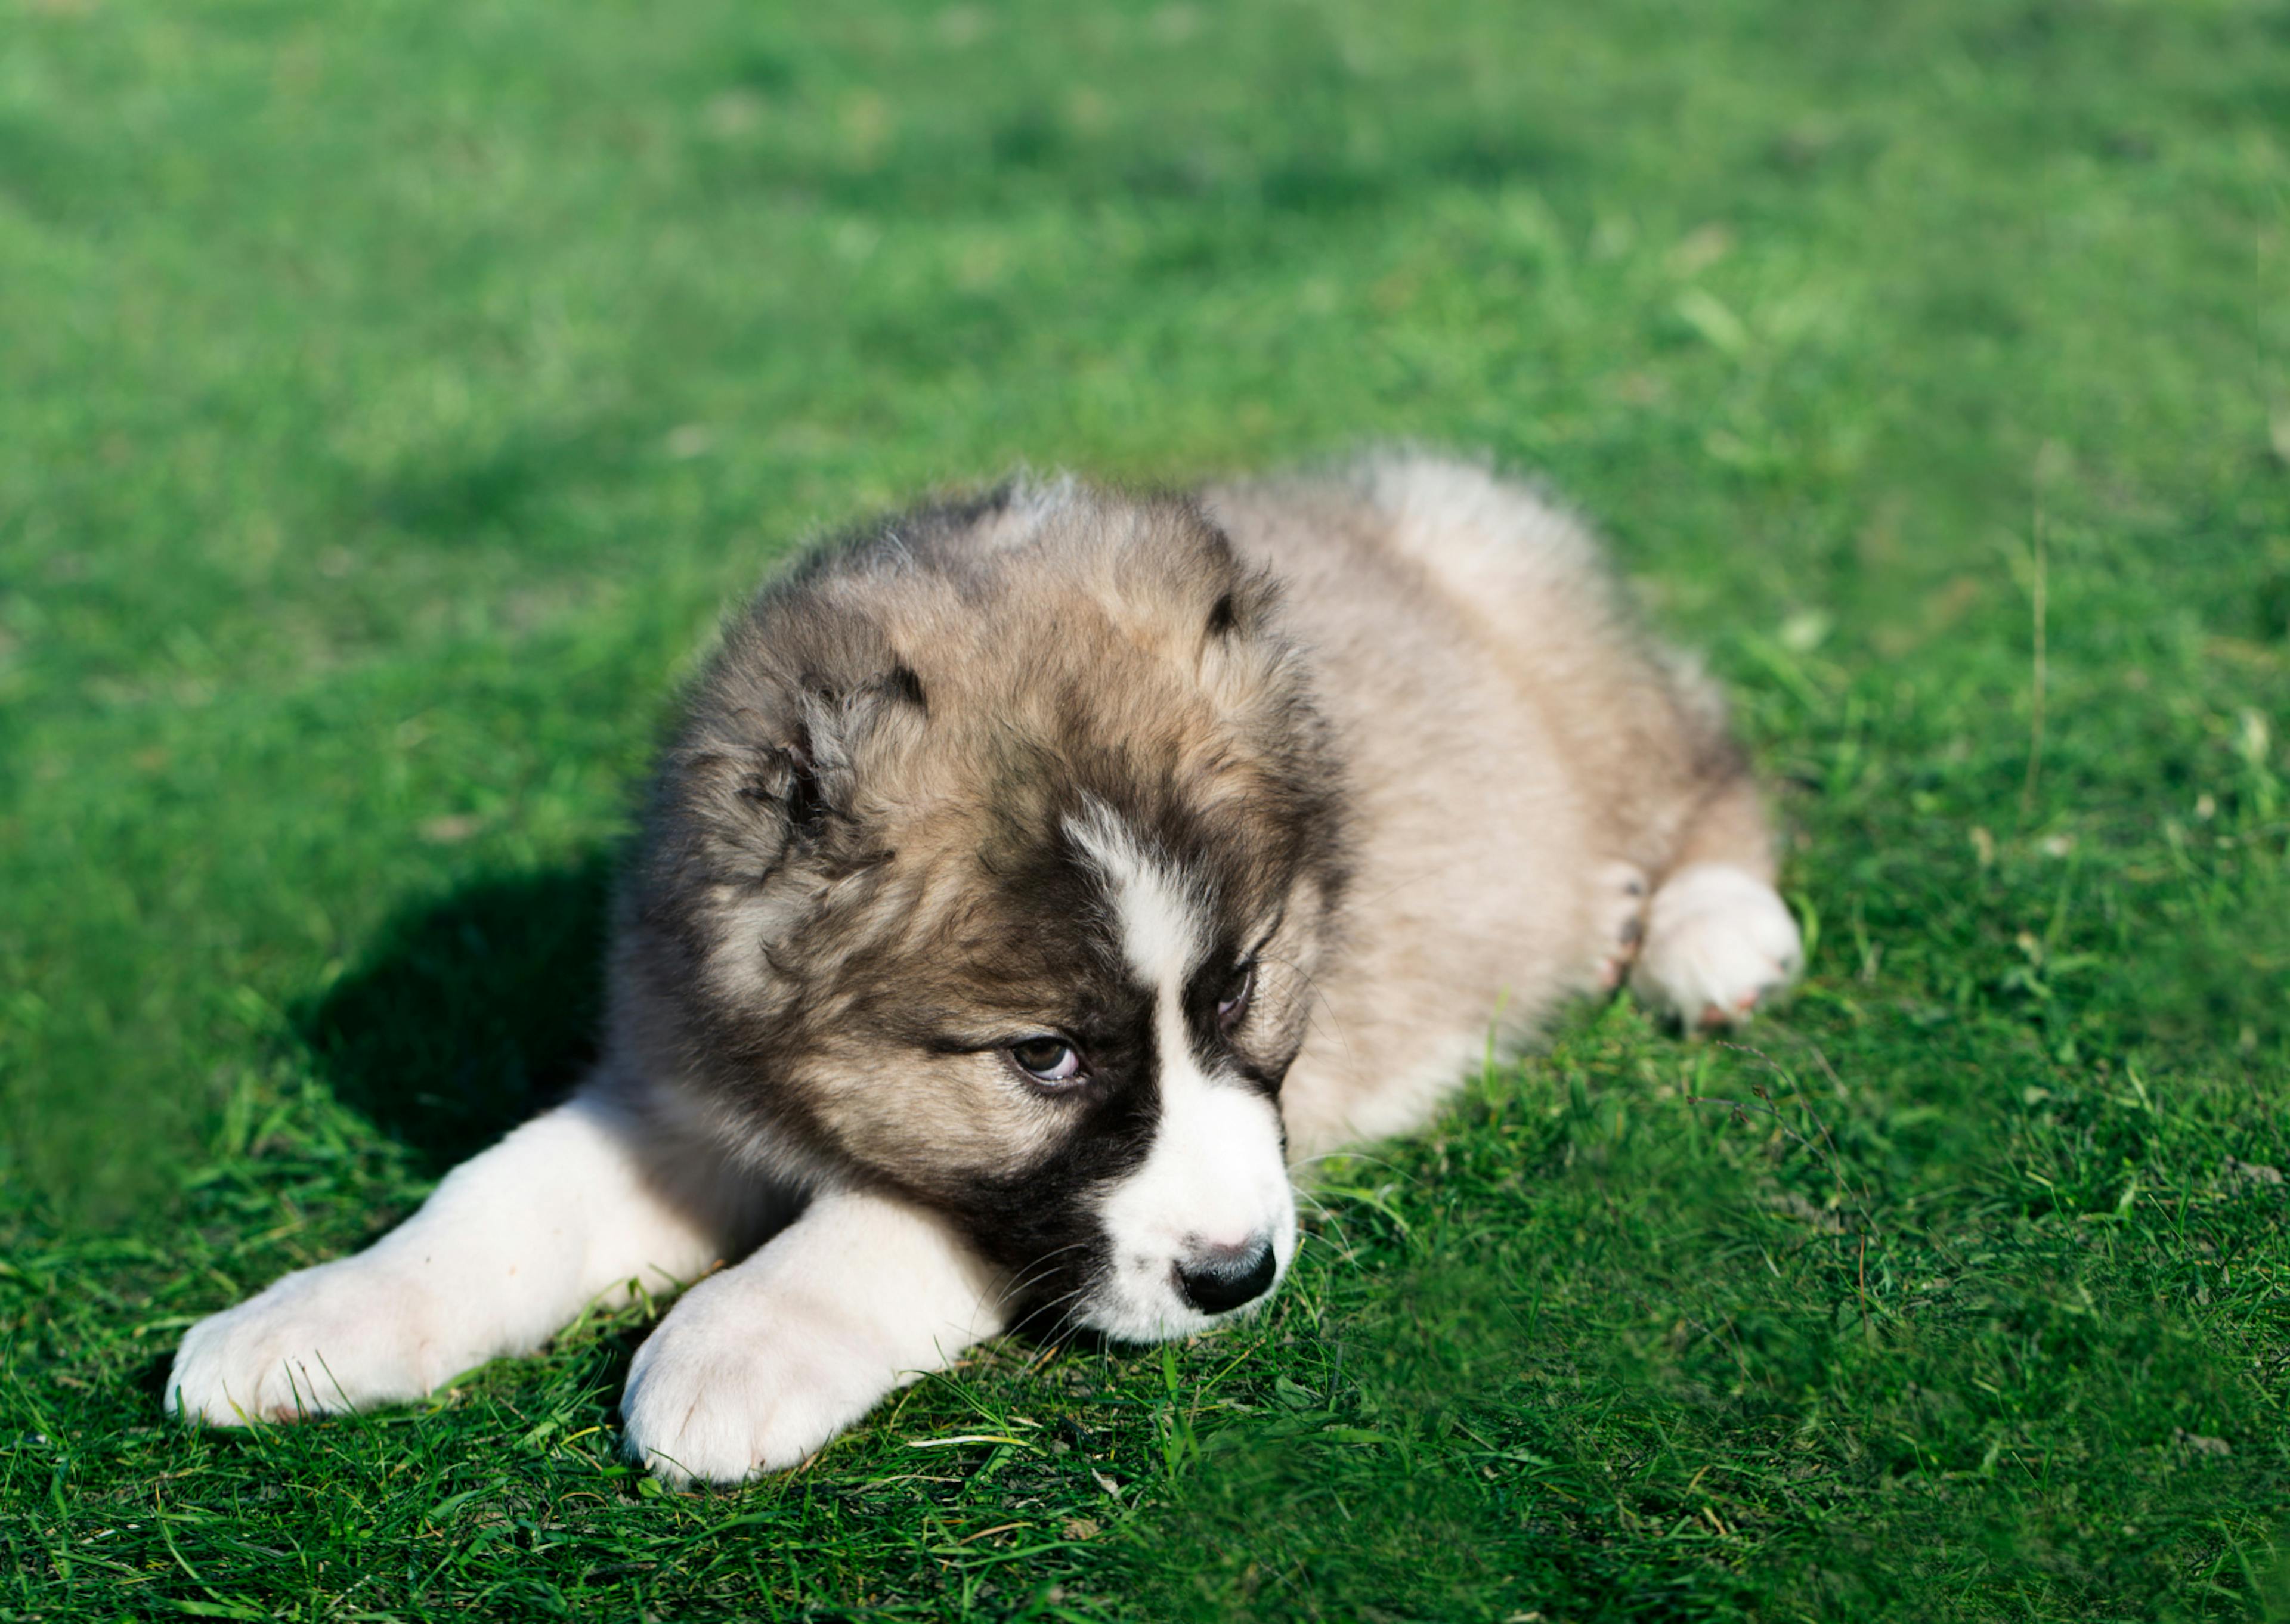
[1630,863,1805,1026]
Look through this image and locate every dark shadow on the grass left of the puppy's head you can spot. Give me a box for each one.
[291,850,611,1173]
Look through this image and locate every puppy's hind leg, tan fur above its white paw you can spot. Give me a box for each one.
[1630,779,1805,1028]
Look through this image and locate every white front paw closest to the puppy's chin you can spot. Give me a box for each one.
[621,1273,911,1482]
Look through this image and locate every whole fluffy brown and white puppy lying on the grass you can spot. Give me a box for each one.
[165,456,1800,1482]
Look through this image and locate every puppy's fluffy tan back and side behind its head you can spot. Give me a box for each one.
[1207,454,1740,1154]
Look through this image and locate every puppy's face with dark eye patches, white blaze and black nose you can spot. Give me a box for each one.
[804,795,1324,1340]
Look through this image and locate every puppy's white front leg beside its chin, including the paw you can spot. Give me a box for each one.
[621,1191,1008,1482]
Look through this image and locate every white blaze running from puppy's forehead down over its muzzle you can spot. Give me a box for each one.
[1065,802,1296,1340]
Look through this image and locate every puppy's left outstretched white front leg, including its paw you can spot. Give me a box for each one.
[167,1083,760,1427]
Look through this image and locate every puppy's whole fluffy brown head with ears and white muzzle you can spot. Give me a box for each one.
[618,486,1342,1340]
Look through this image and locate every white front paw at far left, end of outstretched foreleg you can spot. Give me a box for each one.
[165,1257,456,1427]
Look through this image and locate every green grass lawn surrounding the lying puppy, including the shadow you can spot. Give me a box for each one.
[0,0,2290,1624]
